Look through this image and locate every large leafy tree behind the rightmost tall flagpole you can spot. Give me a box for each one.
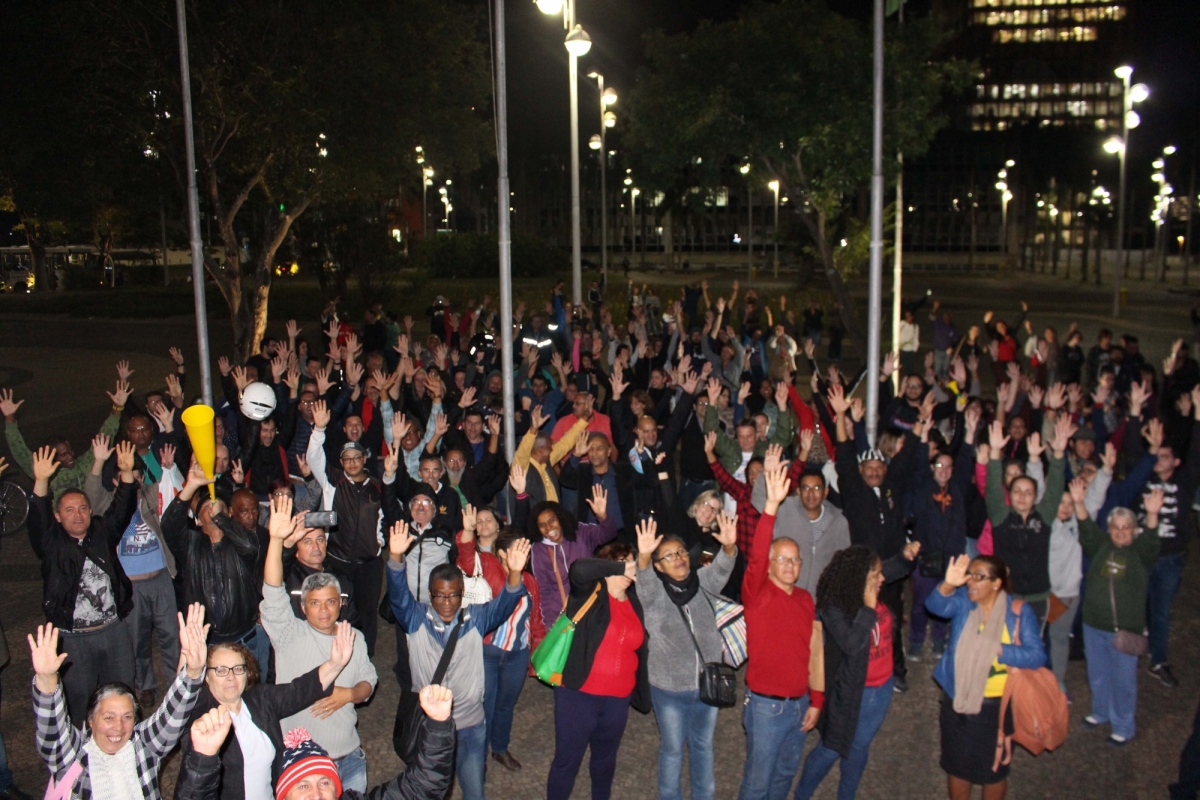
[626,0,970,347]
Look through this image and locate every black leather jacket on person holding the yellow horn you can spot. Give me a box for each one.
[162,498,266,644]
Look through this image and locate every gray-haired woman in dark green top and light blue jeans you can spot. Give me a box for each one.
[1079,489,1164,747]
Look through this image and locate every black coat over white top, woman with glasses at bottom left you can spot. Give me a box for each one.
[175,667,334,800]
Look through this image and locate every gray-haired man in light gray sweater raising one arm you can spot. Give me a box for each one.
[258,497,379,792]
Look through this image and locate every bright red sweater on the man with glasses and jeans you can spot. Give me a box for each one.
[742,515,823,708]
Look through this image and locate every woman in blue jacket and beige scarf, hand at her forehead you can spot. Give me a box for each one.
[925,555,1046,800]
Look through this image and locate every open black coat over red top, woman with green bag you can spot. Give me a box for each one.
[563,559,652,714]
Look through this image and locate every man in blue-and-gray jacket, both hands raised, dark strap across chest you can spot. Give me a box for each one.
[388,522,529,800]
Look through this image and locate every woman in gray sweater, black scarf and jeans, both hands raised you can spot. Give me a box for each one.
[637,511,738,800]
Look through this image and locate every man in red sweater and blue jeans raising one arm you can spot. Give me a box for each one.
[738,465,824,800]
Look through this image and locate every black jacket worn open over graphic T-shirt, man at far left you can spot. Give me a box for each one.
[28,483,138,631]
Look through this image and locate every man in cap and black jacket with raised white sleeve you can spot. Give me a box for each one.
[307,401,400,655]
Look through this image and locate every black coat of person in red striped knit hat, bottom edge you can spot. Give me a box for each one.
[175,718,457,800]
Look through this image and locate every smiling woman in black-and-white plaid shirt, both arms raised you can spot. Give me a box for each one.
[26,603,209,800]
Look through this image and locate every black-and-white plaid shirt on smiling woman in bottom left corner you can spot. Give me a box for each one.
[34,669,204,800]
